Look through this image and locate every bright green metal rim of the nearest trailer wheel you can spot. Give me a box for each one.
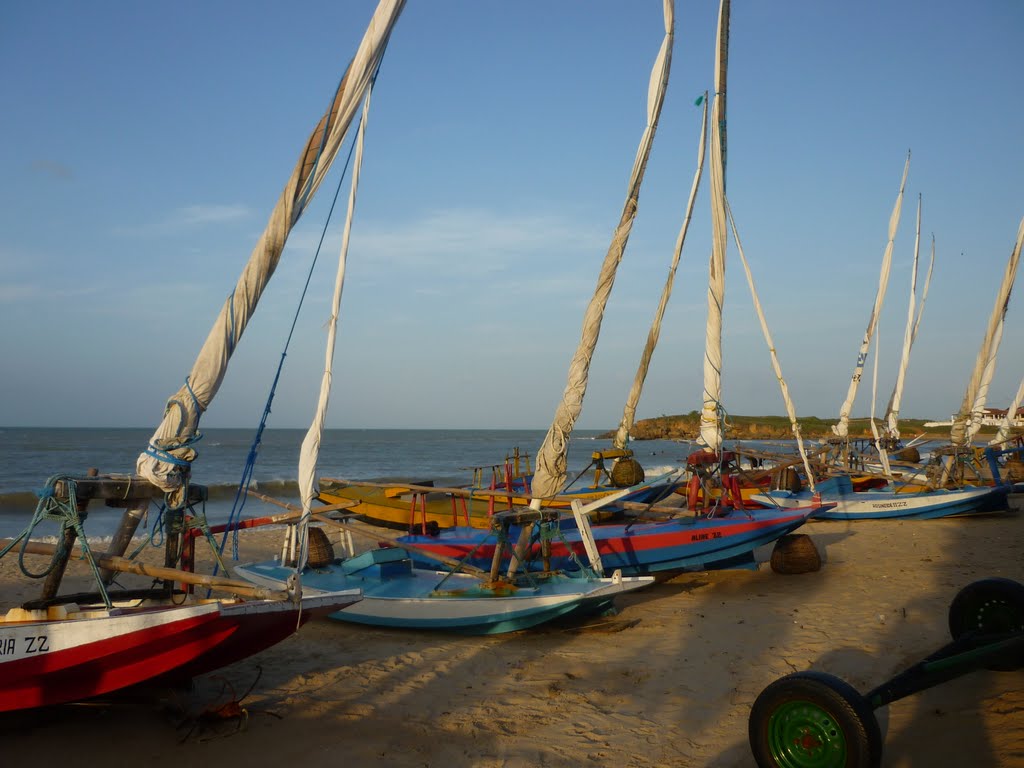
[768,701,847,768]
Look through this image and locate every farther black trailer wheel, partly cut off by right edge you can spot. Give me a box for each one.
[949,578,1024,672]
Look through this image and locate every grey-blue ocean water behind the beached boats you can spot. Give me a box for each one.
[0,427,692,540]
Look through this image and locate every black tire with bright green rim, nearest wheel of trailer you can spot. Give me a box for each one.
[749,672,882,768]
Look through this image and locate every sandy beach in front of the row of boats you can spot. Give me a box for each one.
[0,496,1024,768]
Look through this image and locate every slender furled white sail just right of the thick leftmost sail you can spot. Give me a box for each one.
[295,84,373,571]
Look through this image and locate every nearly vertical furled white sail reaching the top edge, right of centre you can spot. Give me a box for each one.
[699,0,729,453]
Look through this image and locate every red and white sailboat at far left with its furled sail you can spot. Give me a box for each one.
[0,0,404,712]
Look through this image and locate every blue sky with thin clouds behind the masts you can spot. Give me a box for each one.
[0,0,1024,429]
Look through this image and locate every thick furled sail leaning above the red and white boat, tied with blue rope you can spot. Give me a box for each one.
[136,0,406,504]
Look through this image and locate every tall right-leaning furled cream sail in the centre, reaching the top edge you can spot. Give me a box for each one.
[532,0,675,507]
